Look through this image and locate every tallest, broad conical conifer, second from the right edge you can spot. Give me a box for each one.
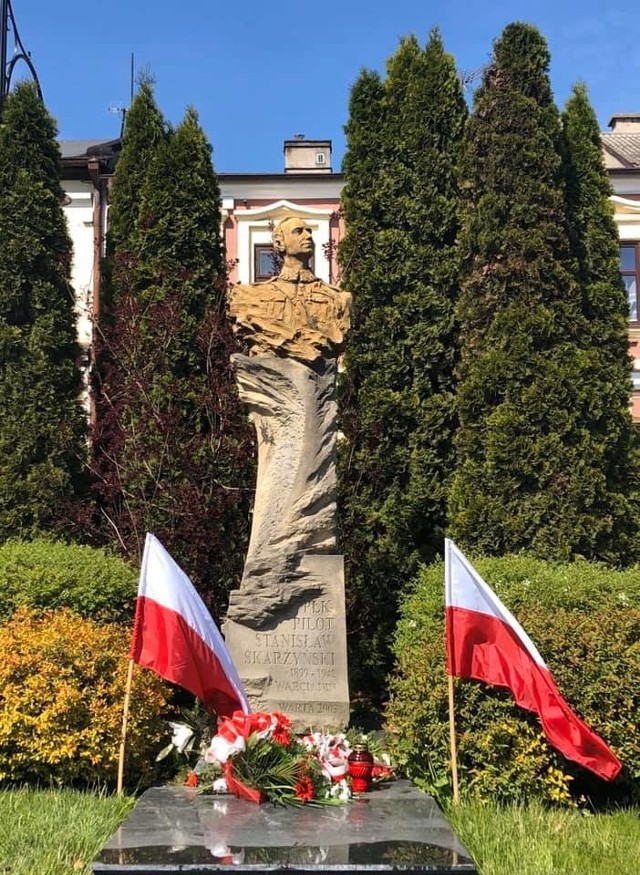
[451,22,636,559]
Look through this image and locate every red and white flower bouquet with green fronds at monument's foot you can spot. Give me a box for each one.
[204,711,351,805]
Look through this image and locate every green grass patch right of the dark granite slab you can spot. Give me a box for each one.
[447,803,640,875]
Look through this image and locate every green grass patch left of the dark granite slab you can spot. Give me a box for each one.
[0,789,135,875]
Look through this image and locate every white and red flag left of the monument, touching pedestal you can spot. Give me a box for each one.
[129,534,251,717]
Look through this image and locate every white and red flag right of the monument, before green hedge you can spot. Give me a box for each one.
[445,539,622,781]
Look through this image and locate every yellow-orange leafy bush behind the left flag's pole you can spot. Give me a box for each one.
[0,608,170,784]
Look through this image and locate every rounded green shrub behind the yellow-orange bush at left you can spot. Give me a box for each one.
[0,539,138,621]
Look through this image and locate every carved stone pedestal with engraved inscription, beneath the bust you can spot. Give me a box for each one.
[224,355,349,732]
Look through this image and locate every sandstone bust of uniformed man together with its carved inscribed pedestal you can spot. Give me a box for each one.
[224,216,352,731]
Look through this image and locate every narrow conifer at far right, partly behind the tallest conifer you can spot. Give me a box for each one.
[562,83,638,562]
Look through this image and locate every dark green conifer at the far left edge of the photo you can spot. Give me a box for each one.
[0,83,86,539]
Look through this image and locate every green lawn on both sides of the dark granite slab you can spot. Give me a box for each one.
[0,789,640,875]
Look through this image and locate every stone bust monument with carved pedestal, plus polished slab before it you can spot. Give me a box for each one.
[92,218,476,875]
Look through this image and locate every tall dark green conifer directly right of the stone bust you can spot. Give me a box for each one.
[339,31,466,692]
